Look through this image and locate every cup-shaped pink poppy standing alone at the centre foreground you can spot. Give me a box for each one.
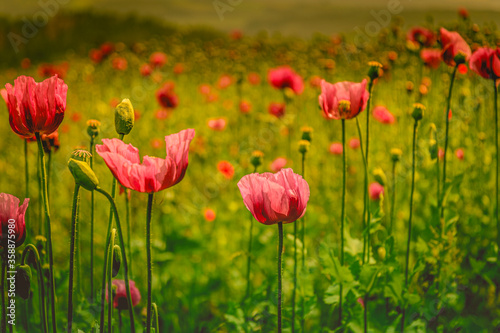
[238,169,310,225]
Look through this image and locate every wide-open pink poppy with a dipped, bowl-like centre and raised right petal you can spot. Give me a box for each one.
[96,129,195,193]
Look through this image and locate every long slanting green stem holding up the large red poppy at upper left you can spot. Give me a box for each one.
[35,132,57,333]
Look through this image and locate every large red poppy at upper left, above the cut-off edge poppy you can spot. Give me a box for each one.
[5,76,68,138]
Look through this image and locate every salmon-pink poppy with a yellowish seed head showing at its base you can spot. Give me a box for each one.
[318,79,370,119]
